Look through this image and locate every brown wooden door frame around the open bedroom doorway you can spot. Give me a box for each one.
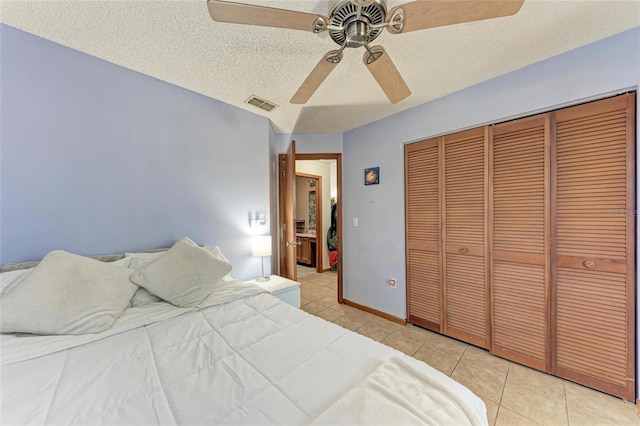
[278,153,344,303]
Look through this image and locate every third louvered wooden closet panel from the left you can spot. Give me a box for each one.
[489,114,550,371]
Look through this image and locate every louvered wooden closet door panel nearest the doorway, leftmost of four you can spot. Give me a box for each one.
[405,139,442,332]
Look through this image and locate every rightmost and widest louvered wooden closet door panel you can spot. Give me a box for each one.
[553,95,635,399]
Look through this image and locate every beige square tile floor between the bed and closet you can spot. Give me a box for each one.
[298,272,640,426]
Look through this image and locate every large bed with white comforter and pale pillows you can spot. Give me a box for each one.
[0,240,487,425]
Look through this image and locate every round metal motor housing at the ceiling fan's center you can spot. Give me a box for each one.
[329,0,387,47]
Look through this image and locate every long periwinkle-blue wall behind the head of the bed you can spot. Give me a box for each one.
[0,25,275,278]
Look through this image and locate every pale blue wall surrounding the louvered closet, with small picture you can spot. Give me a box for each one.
[343,28,640,318]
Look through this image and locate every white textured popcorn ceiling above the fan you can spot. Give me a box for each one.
[0,0,640,133]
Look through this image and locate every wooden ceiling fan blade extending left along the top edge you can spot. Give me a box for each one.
[207,0,328,31]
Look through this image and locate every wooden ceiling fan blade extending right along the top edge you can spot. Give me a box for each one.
[387,0,524,34]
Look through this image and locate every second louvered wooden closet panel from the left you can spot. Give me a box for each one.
[441,128,489,348]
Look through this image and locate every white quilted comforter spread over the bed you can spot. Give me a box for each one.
[0,286,487,425]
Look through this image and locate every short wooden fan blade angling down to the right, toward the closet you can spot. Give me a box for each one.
[362,46,411,104]
